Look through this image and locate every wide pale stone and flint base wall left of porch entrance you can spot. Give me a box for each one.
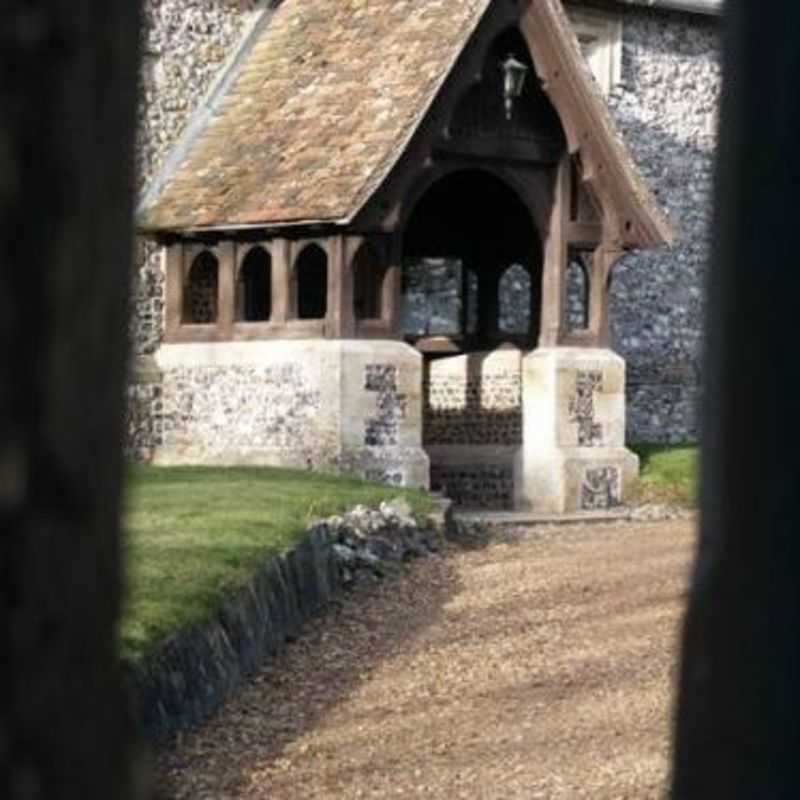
[153,339,428,487]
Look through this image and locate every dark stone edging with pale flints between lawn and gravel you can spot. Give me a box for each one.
[126,500,451,741]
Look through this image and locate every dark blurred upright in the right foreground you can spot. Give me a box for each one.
[673,0,800,800]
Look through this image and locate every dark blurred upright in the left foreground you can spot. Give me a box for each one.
[0,0,144,800]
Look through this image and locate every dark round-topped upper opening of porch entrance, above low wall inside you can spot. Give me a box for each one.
[402,169,542,352]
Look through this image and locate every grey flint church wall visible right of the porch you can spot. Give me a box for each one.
[610,9,720,442]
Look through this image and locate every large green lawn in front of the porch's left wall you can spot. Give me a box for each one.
[121,467,431,661]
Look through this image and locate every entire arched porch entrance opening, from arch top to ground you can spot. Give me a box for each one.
[402,169,542,509]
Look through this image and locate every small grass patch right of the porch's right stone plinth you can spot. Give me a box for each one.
[631,444,699,507]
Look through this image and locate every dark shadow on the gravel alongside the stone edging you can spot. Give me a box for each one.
[148,537,472,800]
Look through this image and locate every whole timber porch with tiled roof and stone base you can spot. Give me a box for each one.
[132,0,720,513]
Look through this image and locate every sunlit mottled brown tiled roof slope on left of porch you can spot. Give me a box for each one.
[139,0,491,230]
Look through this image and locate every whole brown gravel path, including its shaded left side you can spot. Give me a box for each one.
[153,520,694,800]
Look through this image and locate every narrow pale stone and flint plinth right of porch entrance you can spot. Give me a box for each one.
[514,347,639,514]
